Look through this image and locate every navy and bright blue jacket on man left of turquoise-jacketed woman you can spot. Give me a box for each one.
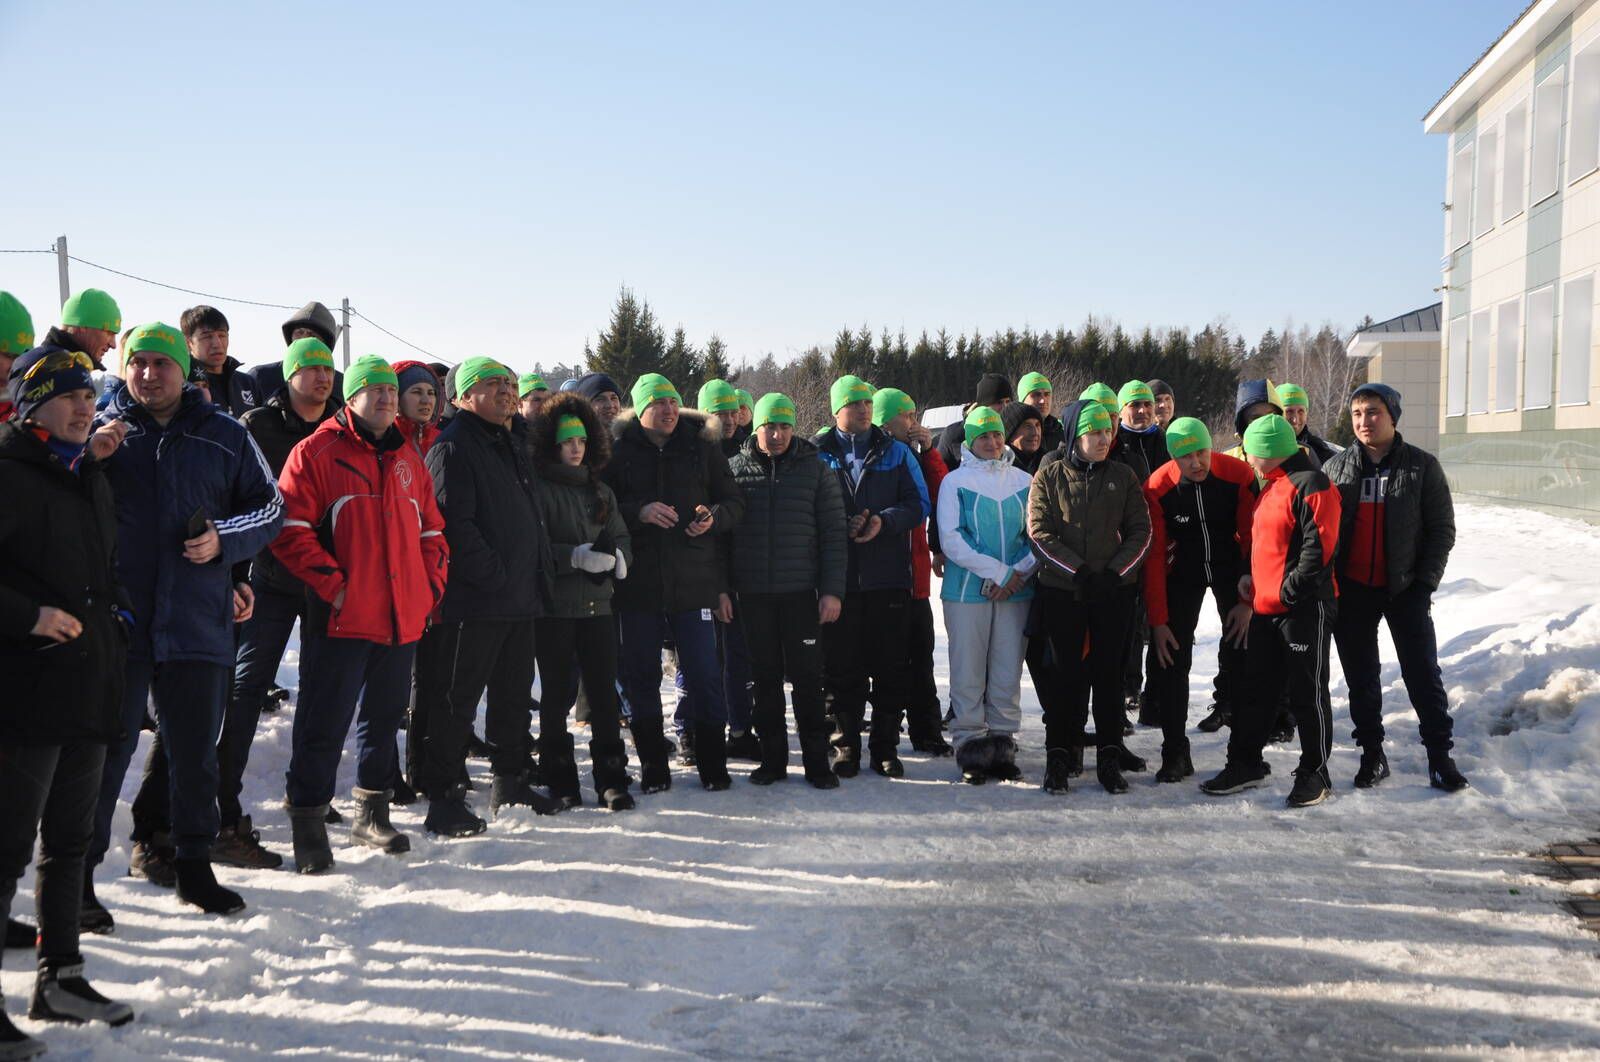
[811,427,933,595]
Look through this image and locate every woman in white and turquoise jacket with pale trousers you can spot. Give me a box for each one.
[939,406,1037,785]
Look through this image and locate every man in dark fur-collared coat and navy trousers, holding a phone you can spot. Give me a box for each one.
[603,373,744,793]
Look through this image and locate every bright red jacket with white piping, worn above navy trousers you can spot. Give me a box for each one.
[272,409,450,645]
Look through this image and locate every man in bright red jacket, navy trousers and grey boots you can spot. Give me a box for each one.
[272,357,450,873]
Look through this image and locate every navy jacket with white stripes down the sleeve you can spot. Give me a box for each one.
[101,387,283,667]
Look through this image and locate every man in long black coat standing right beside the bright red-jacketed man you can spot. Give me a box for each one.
[416,357,563,836]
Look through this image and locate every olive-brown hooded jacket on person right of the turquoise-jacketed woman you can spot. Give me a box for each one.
[1027,400,1152,598]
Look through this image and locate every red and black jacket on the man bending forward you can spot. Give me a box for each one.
[1144,453,1256,627]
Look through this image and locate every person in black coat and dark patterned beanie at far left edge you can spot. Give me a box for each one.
[0,349,133,1036]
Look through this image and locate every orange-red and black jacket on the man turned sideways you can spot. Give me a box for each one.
[1250,451,1341,616]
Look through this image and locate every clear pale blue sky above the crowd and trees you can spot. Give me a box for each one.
[0,0,1522,368]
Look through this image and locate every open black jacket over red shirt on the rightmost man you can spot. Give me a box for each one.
[1322,435,1456,593]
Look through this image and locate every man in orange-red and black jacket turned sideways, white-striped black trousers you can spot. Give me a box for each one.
[1200,413,1341,808]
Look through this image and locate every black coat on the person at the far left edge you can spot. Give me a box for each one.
[0,422,130,744]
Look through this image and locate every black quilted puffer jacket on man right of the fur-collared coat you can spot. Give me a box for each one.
[730,435,848,598]
